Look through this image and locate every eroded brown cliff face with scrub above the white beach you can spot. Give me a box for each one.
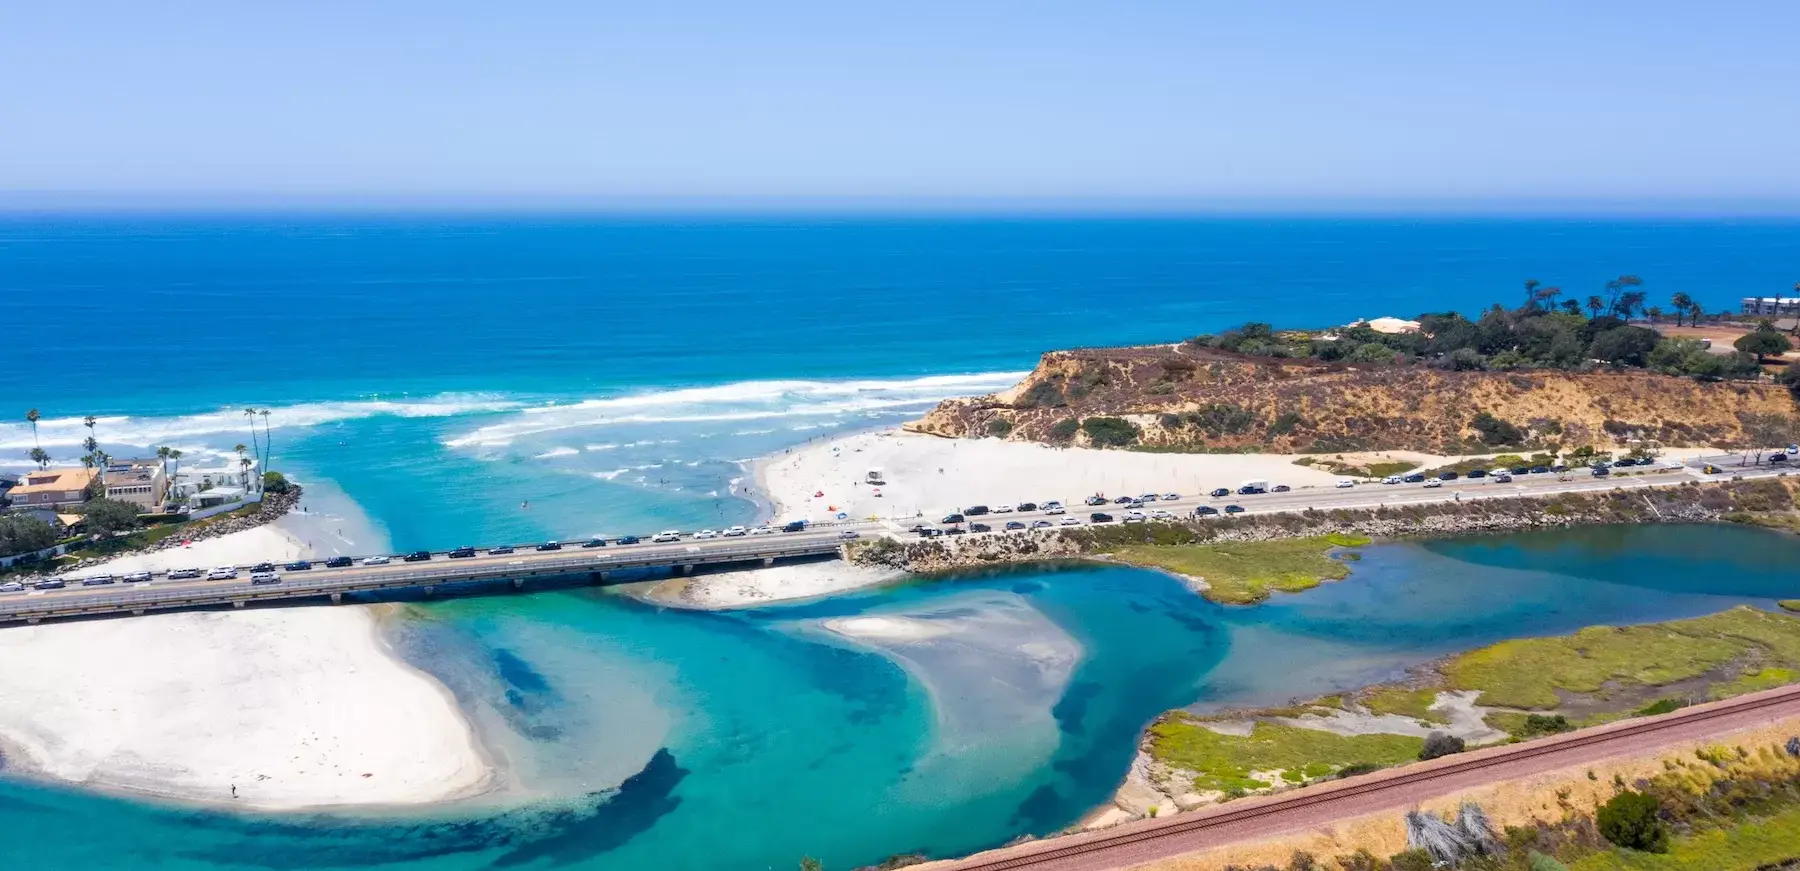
[907,346,1795,453]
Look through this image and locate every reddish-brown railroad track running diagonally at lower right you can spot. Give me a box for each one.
[947,686,1800,871]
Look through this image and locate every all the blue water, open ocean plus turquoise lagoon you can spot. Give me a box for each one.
[10,218,1800,871]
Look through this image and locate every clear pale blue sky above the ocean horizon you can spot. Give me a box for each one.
[0,0,1800,207]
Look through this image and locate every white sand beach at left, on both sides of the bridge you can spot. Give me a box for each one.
[0,525,493,810]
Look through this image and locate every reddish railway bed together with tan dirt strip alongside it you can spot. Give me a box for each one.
[943,686,1800,871]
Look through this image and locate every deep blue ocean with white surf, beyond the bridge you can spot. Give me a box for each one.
[0,216,1800,549]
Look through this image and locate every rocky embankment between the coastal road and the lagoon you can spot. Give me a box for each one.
[850,479,1795,572]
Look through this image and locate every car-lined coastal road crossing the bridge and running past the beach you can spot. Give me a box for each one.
[0,457,1786,623]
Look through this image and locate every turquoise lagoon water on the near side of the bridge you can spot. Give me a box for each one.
[10,525,1800,871]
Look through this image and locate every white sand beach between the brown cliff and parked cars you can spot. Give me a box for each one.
[756,430,1337,520]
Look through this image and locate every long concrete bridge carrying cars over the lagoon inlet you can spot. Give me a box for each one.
[0,529,842,623]
